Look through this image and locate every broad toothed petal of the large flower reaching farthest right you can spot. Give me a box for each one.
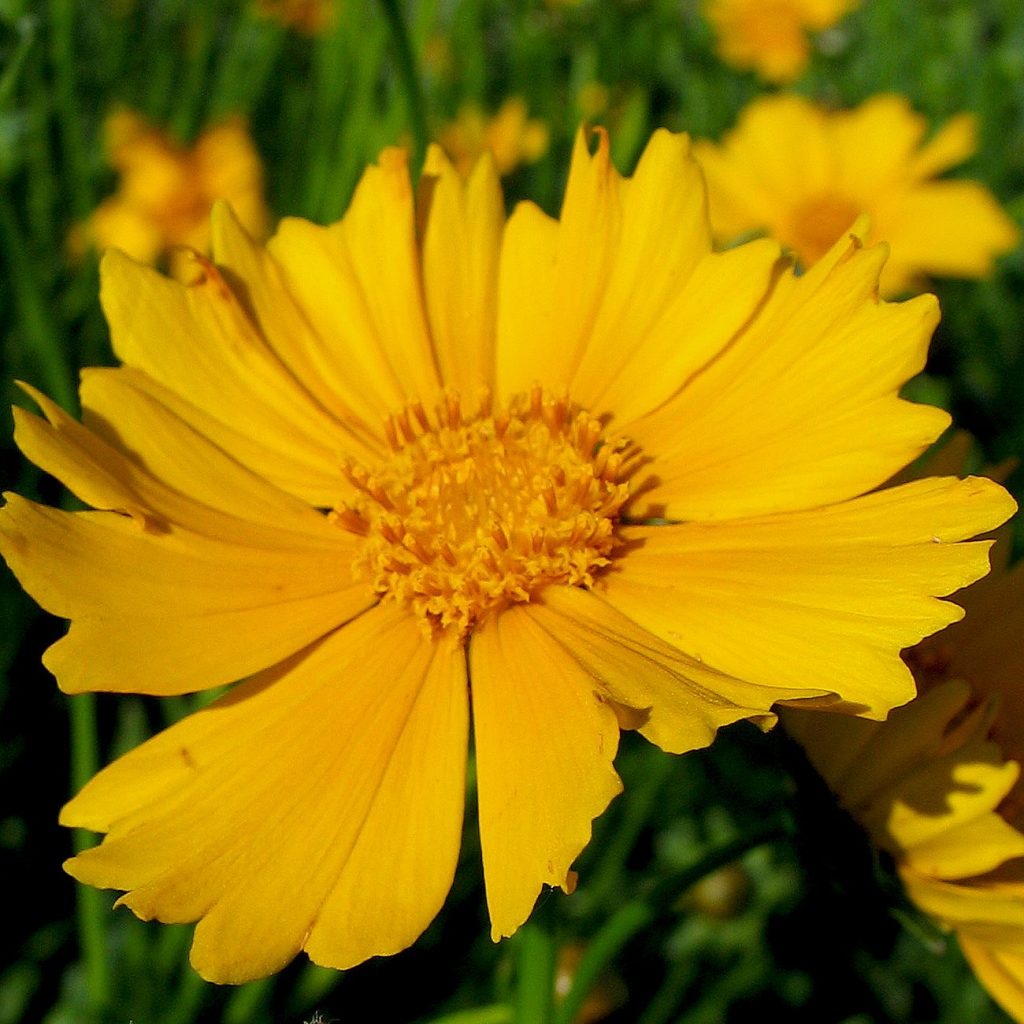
[600,478,1014,718]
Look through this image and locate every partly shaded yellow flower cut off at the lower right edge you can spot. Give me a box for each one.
[784,475,1024,1021]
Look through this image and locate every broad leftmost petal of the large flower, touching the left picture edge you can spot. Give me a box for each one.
[0,495,372,693]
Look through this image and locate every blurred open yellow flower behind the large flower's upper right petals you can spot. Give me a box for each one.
[694,95,1020,295]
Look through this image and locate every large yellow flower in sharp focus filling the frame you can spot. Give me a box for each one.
[0,131,1014,982]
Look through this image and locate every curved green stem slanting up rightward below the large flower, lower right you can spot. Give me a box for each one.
[554,818,788,1024]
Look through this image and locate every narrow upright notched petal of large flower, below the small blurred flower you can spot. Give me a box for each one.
[421,146,505,398]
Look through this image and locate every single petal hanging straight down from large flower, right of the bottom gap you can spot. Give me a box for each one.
[469,606,622,941]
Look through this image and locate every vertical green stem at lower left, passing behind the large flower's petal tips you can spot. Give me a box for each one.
[69,693,111,1010]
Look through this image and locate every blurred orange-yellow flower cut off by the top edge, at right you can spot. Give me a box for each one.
[703,0,857,83]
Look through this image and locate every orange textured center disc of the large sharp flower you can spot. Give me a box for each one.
[332,387,631,638]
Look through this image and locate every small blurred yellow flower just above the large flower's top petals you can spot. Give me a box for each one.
[438,96,548,176]
